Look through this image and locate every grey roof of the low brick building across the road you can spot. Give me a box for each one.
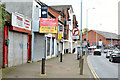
[93,30,118,39]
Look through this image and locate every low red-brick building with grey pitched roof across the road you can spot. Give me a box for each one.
[83,30,119,48]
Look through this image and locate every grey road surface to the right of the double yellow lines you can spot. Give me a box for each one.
[88,53,119,78]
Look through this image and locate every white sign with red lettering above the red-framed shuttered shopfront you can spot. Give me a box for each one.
[12,13,31,31]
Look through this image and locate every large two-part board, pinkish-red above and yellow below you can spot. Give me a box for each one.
[39,18,58,33]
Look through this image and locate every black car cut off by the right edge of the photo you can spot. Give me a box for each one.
[109,51,120,62]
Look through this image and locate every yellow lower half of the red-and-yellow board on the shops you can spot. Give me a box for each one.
[39,26,58,33]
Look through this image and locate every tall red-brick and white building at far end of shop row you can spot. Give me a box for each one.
[51,5,77,53]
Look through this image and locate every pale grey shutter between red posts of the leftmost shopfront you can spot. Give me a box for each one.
[8,31,27,67]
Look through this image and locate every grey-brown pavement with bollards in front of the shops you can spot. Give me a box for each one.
[2,54,92,78]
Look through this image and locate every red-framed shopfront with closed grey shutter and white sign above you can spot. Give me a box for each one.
[3,13,31,67]
